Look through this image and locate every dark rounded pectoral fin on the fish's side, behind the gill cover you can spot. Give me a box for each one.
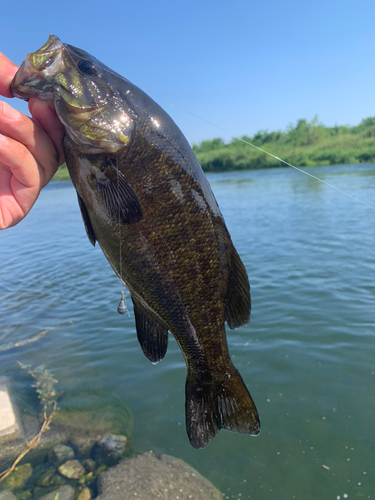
[95,160,143,224]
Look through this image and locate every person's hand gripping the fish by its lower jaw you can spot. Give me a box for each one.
[0,52,64,229]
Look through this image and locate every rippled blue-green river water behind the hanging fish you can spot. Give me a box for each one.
[0,164,375,500]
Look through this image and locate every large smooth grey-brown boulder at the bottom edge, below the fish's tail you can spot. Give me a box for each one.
[95,453,223,500]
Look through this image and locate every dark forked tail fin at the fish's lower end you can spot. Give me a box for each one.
[186,365,260,448]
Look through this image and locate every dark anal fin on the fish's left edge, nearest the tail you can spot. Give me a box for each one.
[133,299,168,363]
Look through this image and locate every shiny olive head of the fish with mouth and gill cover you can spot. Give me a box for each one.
[11,35,134,154]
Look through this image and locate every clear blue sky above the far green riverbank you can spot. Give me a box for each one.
[0,0,375,143]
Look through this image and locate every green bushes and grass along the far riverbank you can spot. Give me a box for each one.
[54,117,375,180]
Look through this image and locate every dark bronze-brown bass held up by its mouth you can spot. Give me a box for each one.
[11,35,260,449]
